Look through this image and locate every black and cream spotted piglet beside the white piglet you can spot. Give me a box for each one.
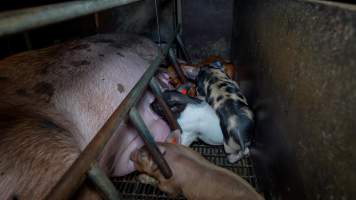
[196,61,254,163]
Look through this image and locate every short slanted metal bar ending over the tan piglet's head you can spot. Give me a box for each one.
[129,107,172,179]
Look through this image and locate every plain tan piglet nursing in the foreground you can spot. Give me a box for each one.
[130,132,263,200]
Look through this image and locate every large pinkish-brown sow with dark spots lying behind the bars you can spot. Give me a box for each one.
[0,34,169,199]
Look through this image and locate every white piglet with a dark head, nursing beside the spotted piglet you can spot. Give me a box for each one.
[151,90,224,146]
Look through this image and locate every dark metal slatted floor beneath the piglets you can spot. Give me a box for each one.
[112,142,259,200]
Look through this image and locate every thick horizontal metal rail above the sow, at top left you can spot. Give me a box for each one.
[0,0,139,36]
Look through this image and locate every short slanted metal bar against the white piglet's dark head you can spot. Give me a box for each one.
[149,77,181,130]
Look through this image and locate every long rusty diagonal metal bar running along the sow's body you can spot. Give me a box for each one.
[46,28,177,200]
